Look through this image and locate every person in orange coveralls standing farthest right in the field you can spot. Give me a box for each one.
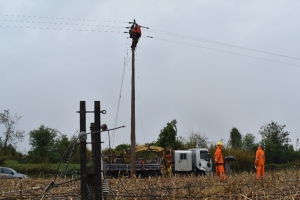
[254,144,266,180]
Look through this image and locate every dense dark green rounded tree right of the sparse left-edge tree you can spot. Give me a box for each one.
[28,125,58,163]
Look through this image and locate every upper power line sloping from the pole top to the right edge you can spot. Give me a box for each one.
[144,29,300,60]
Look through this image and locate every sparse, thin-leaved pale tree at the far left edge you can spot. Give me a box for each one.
[0,110,25,151]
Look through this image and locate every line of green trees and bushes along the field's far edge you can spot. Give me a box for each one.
[0,110,300,170]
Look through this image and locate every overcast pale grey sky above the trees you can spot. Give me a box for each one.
[0,0,300,151]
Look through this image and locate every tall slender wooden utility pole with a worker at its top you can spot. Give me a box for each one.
[130,45,136,177]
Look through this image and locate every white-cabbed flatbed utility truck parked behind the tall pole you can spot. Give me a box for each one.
[104,144,212,176]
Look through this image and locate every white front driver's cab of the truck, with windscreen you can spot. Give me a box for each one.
[189,148,212,175]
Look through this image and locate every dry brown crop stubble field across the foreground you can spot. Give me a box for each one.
[0,169,300,200]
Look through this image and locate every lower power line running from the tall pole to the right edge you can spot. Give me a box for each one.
[153,37,299,67]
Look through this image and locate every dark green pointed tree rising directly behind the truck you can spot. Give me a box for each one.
[157,119,179,149]
